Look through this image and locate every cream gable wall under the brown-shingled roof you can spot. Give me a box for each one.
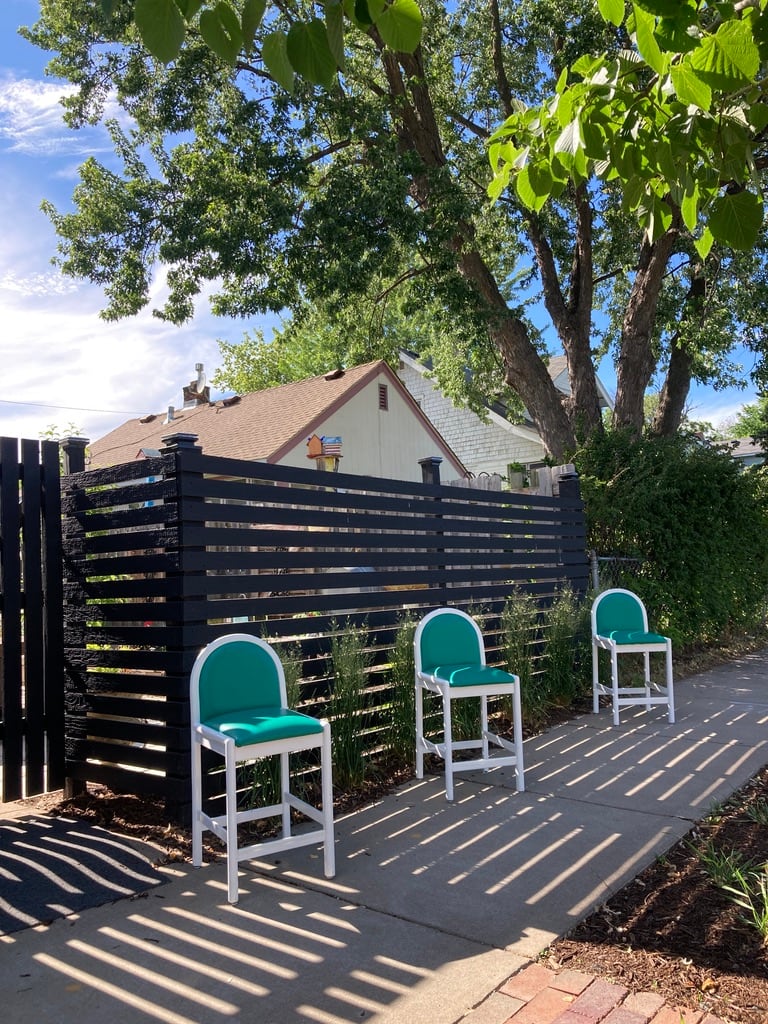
[280,374,464,481]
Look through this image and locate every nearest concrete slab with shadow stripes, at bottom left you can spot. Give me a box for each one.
[0,863,524,1024]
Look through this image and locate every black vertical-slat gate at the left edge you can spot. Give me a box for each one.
[0,437,63,801]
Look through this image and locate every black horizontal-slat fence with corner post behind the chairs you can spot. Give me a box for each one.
[62,435,588,809]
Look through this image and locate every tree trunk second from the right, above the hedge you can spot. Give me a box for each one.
[613,226,677,433]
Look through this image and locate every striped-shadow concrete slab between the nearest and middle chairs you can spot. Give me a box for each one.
[253,773,689,956]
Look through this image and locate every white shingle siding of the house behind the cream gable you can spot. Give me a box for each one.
[398,362,546,480]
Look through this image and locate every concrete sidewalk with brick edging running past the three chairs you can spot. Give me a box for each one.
[0,651,768,1024]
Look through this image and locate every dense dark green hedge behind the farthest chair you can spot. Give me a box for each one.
[574,431,768,644]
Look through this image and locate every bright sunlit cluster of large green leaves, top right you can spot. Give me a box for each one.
[489,0,768,257]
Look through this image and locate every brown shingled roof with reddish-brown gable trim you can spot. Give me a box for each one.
[90,359,458,469]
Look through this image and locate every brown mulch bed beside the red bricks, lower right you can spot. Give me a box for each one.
[545,768,768,1024]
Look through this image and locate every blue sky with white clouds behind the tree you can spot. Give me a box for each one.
[0,0,755,439]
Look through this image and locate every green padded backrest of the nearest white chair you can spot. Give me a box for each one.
[199,640,283,722]
